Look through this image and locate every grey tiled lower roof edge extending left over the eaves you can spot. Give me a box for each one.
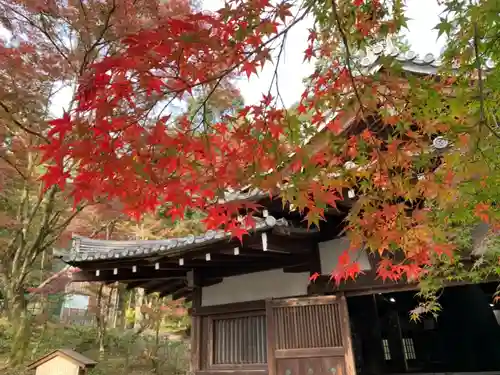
[63,216,288,264]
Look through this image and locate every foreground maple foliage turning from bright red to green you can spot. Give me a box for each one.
[7,0,500,314]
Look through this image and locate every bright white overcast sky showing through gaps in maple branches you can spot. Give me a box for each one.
[0,0,444,116]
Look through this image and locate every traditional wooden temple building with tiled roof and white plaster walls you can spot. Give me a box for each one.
[59,46,500,375]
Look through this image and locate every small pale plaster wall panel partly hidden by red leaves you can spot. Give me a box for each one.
[318,237,371,275]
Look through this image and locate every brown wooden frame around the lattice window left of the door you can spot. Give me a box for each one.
[203,310,267,370]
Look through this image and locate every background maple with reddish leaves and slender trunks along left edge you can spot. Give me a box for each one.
[0,0,235,365]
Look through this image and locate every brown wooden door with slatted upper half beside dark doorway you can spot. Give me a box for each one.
[266,296,356,375]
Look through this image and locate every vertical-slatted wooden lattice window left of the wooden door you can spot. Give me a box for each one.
[211,312,267,366]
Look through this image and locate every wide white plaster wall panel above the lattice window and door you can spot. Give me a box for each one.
[201,269,309,306]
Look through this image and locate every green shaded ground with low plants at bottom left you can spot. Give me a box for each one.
[0,320,189,375]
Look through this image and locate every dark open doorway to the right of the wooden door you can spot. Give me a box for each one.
[347,284,500,375]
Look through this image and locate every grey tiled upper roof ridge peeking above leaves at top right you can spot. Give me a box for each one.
[360,39,495,74]
